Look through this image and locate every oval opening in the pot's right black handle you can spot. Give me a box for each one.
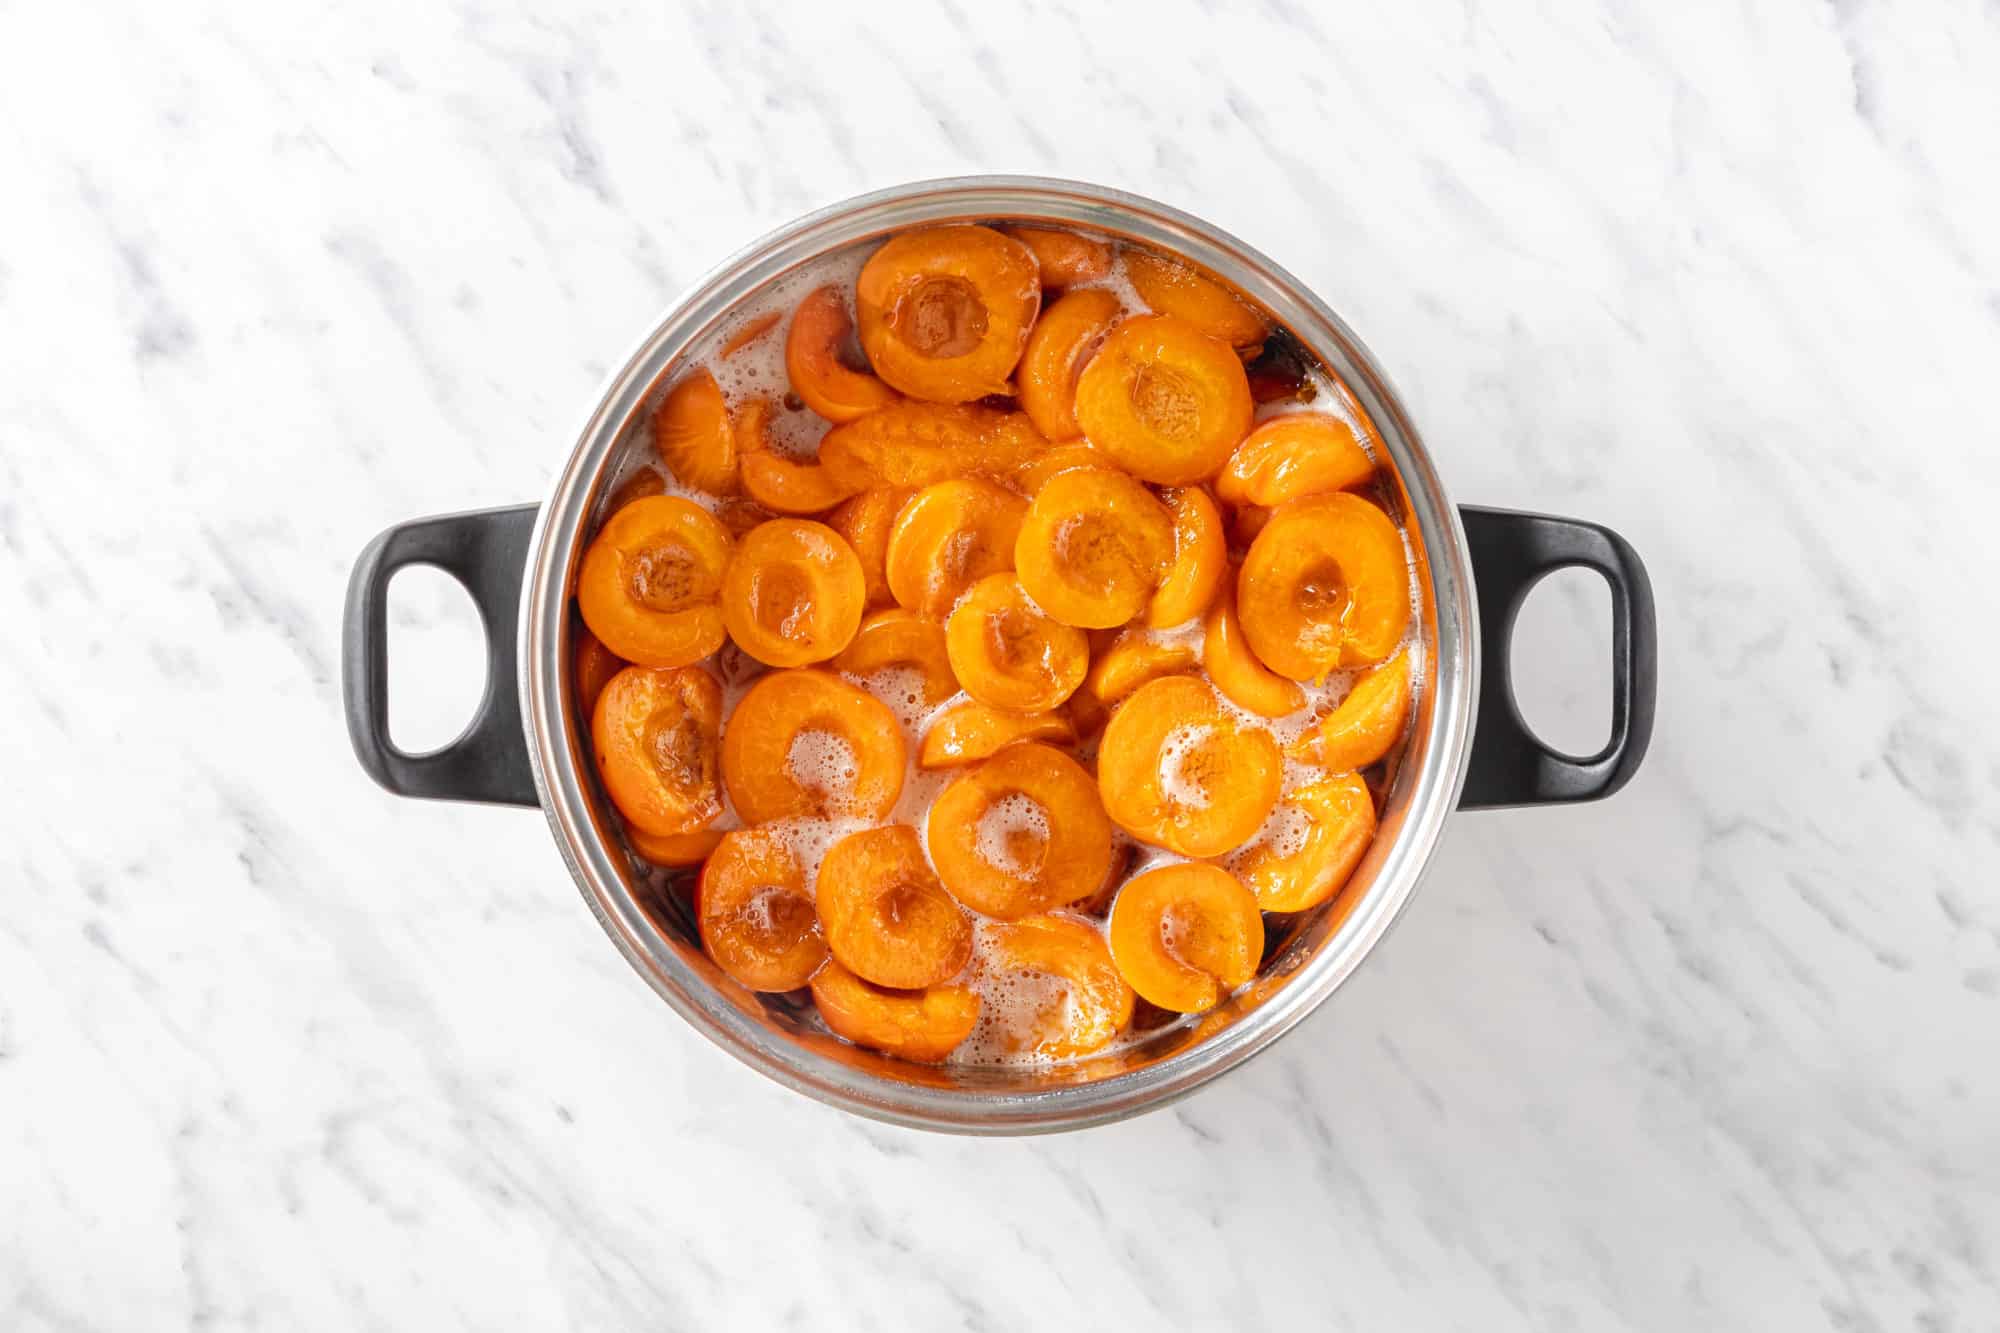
[1508,568,1612,759]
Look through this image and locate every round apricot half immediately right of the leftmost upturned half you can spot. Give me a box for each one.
[722,518,868,667]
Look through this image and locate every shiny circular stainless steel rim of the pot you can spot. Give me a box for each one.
[518,176,1480,1135]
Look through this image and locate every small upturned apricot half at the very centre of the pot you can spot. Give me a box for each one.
[944,574,1090,713]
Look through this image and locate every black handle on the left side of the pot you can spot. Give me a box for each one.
[340,504,538,805]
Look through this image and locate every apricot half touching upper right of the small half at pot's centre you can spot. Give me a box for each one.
[1014,468,1174,628]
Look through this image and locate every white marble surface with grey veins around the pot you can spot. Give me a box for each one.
[0,0,2000,1331]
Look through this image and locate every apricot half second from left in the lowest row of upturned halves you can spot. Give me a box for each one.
[814,825,972,991]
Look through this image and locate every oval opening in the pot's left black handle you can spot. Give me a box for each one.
[388,564,486,755]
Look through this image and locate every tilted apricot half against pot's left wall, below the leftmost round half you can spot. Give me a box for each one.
[590,667,722,835]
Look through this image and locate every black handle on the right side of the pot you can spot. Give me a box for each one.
[1458,504,1658,811]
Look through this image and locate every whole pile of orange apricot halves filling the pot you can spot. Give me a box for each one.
[576,224,1412,1061]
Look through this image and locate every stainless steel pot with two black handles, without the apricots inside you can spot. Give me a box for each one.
[344,176,1654,1135]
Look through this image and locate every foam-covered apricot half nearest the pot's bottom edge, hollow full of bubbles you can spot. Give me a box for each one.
[984,913,1134,1061]
